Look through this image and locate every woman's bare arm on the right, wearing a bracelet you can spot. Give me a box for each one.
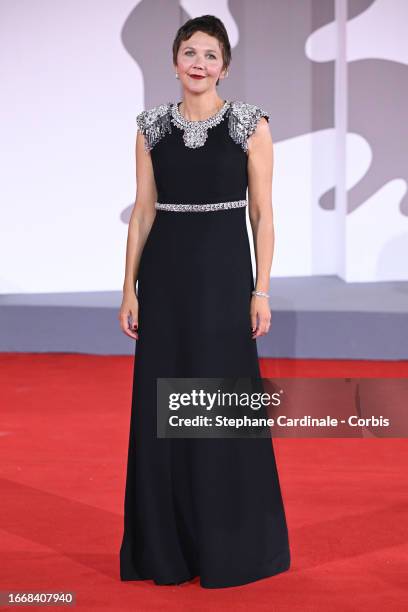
[248,117,275,338]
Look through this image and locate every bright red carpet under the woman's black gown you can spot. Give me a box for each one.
[0,353,408,612]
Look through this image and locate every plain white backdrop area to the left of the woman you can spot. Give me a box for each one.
[0,0,139,293]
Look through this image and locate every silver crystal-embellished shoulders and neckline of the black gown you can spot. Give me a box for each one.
[136,100,269,153]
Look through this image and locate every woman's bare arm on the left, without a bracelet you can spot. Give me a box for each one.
[118,130,157,339]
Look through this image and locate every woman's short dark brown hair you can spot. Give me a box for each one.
[173,15,231,85]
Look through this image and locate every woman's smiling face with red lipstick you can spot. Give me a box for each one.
[176,32,225,92]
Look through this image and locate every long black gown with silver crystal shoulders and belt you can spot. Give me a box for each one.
[120,100,290,588]
